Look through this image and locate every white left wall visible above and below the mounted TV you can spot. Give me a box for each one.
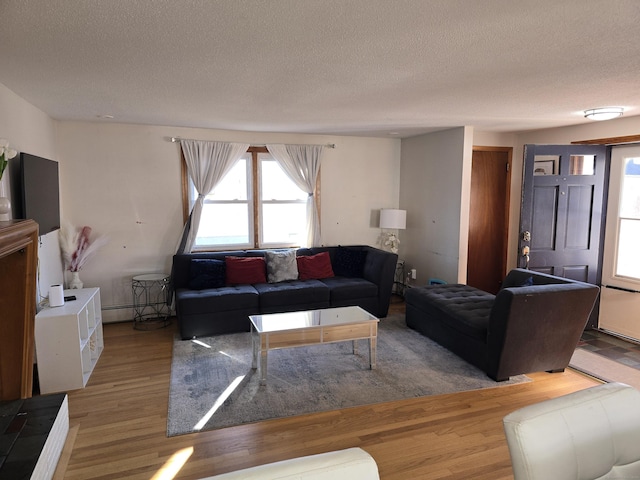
[0,80,62,301]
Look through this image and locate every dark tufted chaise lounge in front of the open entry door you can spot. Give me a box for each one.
[405,269,599,381]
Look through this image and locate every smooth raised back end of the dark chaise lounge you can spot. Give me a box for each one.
[487,281,600,380]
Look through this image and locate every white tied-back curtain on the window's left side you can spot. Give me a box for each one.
[178,140,249,253]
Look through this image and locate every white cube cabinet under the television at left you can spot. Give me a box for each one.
[35,288,104,394]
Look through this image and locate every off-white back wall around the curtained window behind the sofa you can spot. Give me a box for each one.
[57,122,400,322]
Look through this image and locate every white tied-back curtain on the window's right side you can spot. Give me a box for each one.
[267,144,323,247]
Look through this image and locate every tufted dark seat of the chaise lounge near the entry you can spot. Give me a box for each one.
[406,284,495,343]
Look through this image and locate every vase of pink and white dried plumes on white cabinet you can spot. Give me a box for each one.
[59,224,107,289]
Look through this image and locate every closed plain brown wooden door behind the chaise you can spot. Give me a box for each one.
[467,147,512,293]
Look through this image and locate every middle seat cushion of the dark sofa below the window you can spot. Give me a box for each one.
[253,280,329,313]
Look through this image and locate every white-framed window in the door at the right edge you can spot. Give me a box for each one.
[604,147,640,289]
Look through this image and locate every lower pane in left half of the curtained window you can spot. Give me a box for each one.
[196,203,250,246]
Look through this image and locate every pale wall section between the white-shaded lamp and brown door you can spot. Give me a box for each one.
[399,127,473,284]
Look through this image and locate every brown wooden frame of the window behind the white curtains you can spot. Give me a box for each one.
[180,146,321,252]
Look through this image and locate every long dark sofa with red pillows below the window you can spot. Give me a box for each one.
[172,245,398,340]
